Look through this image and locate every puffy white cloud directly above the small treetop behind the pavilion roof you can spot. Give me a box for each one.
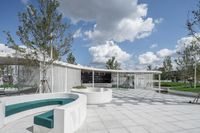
[89,41,131,63]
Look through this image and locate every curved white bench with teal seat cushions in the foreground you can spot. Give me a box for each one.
[0,93,87,133]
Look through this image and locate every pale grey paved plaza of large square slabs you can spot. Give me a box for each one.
[0,89,200,133]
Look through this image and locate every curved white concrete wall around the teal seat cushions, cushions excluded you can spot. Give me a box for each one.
[0,93,87,133]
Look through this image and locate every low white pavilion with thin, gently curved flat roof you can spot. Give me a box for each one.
[0,54,161,92]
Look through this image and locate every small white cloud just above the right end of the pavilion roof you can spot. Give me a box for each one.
[138,52,160,64]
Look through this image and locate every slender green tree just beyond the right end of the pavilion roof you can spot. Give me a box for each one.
[162,56,173,80]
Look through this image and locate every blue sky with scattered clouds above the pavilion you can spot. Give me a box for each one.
[0,0,198,69]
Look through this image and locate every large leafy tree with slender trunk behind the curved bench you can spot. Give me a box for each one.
[6,0,73,92]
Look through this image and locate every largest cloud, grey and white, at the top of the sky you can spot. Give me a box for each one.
[60,0,155,43]
